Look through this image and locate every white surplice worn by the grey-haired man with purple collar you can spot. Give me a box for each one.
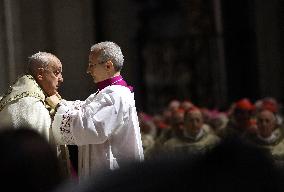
[52,85,144,179]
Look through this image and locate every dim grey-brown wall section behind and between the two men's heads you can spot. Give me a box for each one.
[0,0,95,99]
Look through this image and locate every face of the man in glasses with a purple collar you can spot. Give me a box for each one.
[87,52,109,83]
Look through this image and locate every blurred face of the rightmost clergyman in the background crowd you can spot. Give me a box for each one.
[257,110,276,137]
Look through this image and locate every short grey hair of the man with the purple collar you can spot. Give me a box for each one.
[91,41,124,71]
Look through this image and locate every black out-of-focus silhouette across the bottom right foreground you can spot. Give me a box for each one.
[56,132,284,192]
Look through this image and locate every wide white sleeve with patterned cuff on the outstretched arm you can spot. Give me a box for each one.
[52,94,122,145]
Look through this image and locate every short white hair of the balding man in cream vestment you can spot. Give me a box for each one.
[27,52,60,75]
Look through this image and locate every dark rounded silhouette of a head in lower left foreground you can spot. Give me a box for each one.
[0,127,63,192]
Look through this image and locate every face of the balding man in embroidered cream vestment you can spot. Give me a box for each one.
[38,59,63,96]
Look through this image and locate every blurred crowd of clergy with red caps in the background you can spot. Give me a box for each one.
[139,97,284,165]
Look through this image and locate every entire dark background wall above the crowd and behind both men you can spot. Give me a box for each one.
[0,0,284,113]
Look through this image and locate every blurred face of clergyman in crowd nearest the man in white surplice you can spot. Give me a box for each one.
[184,110,203,135]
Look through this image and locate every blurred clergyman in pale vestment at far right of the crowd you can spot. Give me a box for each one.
[247,109,284,166]
